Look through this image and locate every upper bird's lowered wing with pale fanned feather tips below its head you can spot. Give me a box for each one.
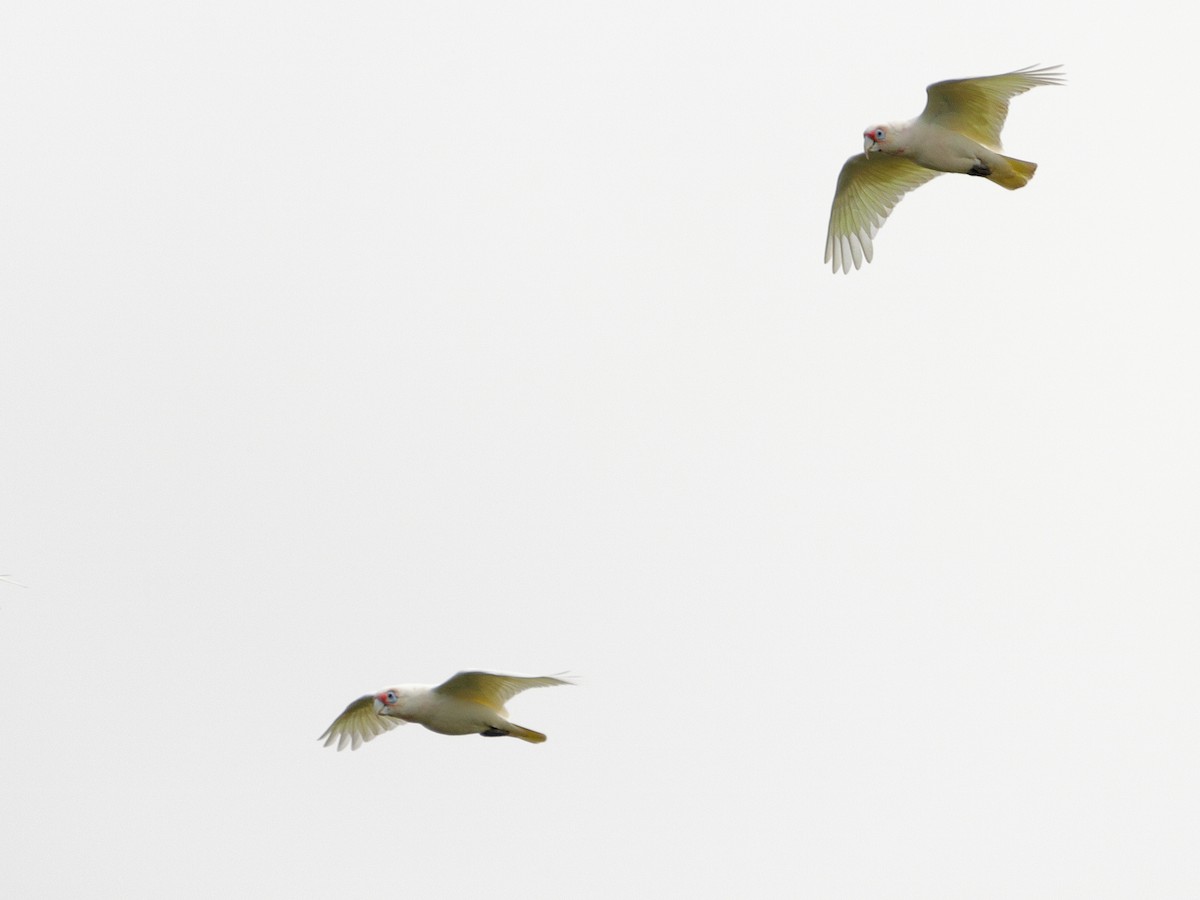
[826,154,941,272]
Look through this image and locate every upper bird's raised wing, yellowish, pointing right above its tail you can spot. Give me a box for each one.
[920,66,1063,150]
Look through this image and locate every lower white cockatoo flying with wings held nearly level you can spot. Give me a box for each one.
[317,672,574,750]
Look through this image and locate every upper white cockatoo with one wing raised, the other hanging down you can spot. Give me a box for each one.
[826,66,1063,272]
